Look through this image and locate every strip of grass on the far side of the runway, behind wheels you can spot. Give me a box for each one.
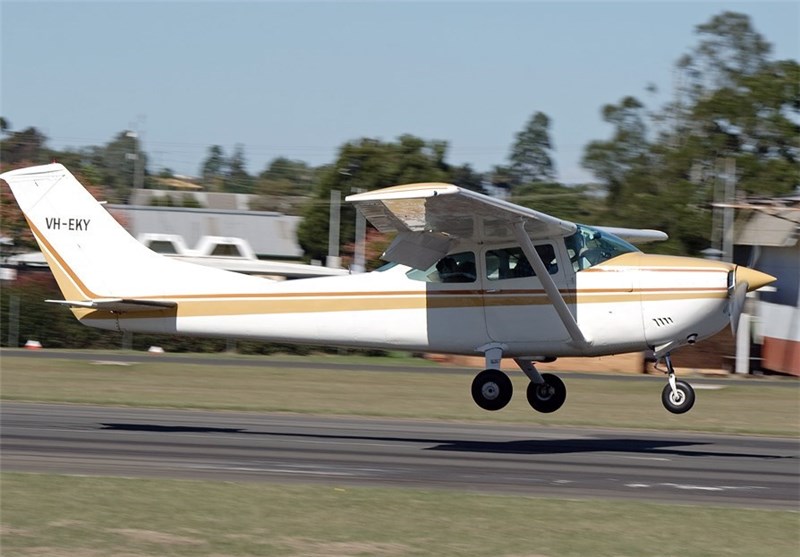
[0,355,800,436]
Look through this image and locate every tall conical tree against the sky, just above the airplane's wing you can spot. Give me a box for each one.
[508,112,555,185]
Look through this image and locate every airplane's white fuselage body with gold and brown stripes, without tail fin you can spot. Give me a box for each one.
[79,242,731,356]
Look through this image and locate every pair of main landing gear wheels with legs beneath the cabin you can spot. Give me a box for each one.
[472,349,567,413]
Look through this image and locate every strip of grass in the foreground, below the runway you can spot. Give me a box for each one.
[2,473,800,557]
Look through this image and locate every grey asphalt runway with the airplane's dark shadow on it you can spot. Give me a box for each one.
[0,402,800,509]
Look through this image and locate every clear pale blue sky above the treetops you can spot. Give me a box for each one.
[0,0,800,183]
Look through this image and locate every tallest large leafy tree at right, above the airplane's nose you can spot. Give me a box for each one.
[583,12,800,253]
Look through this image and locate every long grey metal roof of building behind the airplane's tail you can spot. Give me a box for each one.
[108,205,303,259]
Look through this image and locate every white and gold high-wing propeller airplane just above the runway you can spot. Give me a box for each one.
[0,163,776,414]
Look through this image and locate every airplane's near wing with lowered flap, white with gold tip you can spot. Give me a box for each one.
[346,183,577,269]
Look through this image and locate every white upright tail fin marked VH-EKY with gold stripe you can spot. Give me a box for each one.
[0,164,258,300]
